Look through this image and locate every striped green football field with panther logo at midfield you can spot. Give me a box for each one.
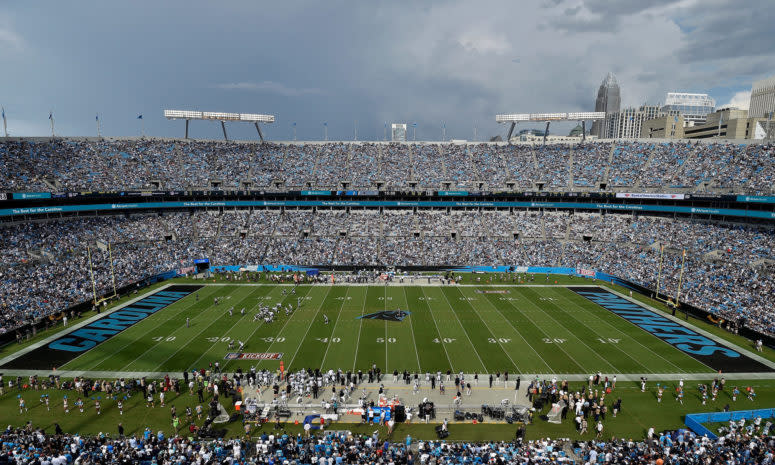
[6,284,768,374]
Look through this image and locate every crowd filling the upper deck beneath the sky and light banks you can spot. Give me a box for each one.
[0,139,775,193]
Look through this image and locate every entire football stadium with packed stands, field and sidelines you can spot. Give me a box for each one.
[0,2,775,465]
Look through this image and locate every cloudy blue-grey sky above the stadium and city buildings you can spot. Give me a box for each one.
[0,0,775,140]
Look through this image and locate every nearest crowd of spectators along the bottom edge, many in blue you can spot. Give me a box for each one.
[0,426,775,465]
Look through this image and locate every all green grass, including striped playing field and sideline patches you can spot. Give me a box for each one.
[0,279,775,440]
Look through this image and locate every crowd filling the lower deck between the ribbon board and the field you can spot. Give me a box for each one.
[0,210,775,334]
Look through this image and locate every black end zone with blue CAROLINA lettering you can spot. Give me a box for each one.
[3,284,203,369]
